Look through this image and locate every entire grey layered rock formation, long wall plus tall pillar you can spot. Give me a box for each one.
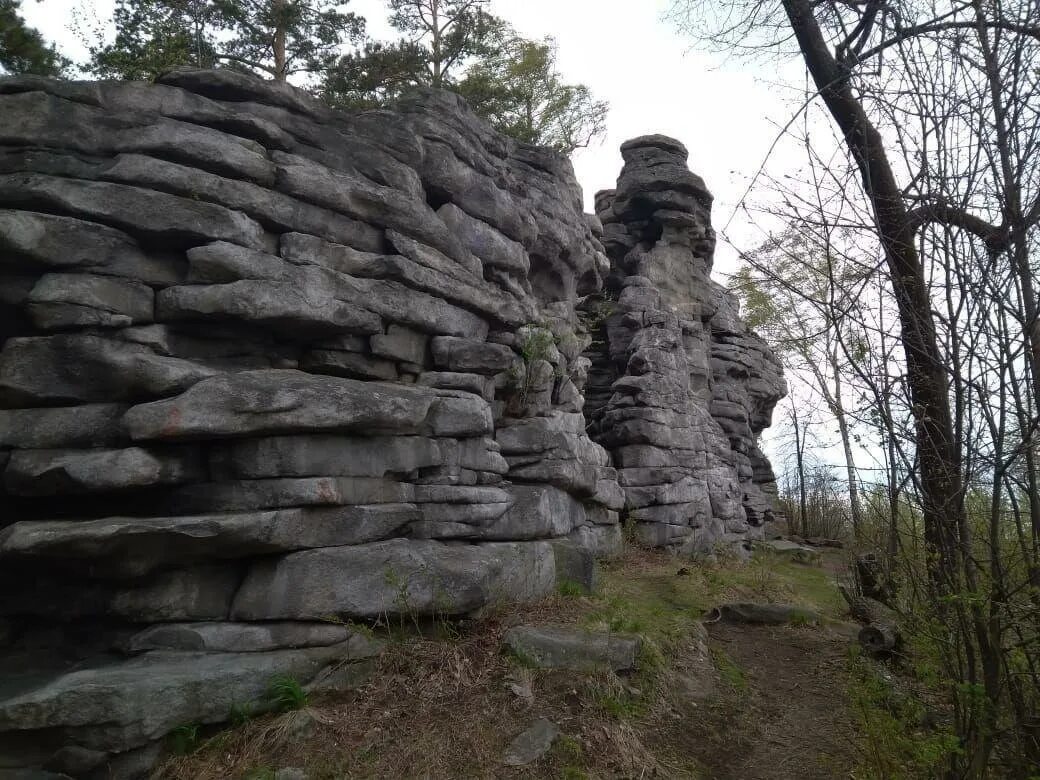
[0,70,782,777]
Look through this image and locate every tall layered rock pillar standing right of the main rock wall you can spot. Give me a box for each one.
[582,135,785,551]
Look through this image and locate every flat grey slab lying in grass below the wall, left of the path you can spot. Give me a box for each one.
[504,626,643,672]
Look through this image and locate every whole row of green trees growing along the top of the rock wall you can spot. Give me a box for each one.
[0,0,607,154]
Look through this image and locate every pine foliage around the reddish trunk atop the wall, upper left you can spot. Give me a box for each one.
[88,0,364,80]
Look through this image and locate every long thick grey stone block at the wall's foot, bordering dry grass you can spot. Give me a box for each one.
[232,539,554,620]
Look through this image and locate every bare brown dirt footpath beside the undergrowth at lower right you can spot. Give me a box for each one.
[701,623,854,780]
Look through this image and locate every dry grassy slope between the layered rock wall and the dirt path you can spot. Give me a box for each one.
[150,550,840,780]
